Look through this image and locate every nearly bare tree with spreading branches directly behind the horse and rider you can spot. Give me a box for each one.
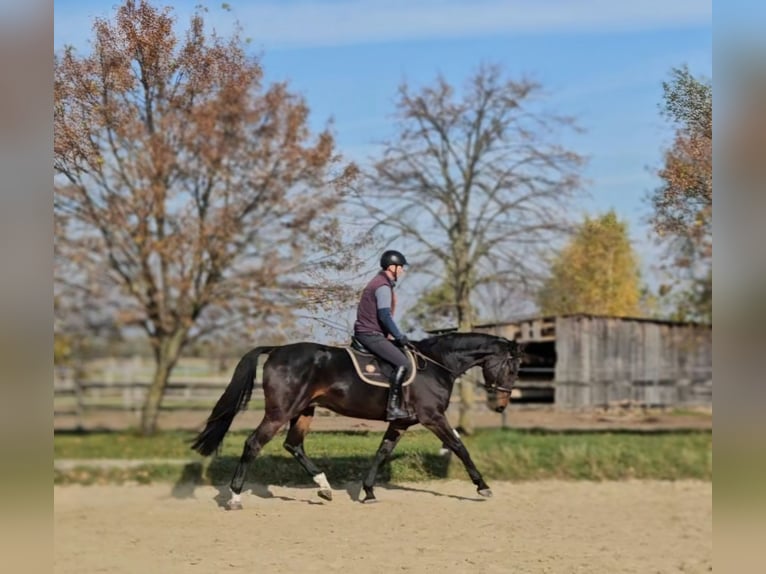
[359,66,583,432]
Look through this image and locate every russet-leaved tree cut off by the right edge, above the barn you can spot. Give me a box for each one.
[650,66,713,321]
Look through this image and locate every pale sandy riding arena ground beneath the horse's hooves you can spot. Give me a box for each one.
[54,480,713,574]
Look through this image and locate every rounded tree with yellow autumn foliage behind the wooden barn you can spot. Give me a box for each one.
[538,211,641,317]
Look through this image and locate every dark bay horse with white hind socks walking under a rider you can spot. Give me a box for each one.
[191,333,522,510]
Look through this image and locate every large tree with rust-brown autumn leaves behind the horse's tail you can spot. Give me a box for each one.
[54,0,354,434]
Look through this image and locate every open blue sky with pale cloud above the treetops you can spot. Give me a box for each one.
[54,0,713,288]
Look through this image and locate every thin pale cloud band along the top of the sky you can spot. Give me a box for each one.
[56,0,712,49]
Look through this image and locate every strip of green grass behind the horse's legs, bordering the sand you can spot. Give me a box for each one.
[54,429,713,484]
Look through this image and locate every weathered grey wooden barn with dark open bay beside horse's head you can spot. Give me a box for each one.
[436,314,713,409]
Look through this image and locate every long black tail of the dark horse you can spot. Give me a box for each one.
[191,347,274,456]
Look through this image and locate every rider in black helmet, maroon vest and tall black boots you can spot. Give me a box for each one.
[354,250,410,421]
